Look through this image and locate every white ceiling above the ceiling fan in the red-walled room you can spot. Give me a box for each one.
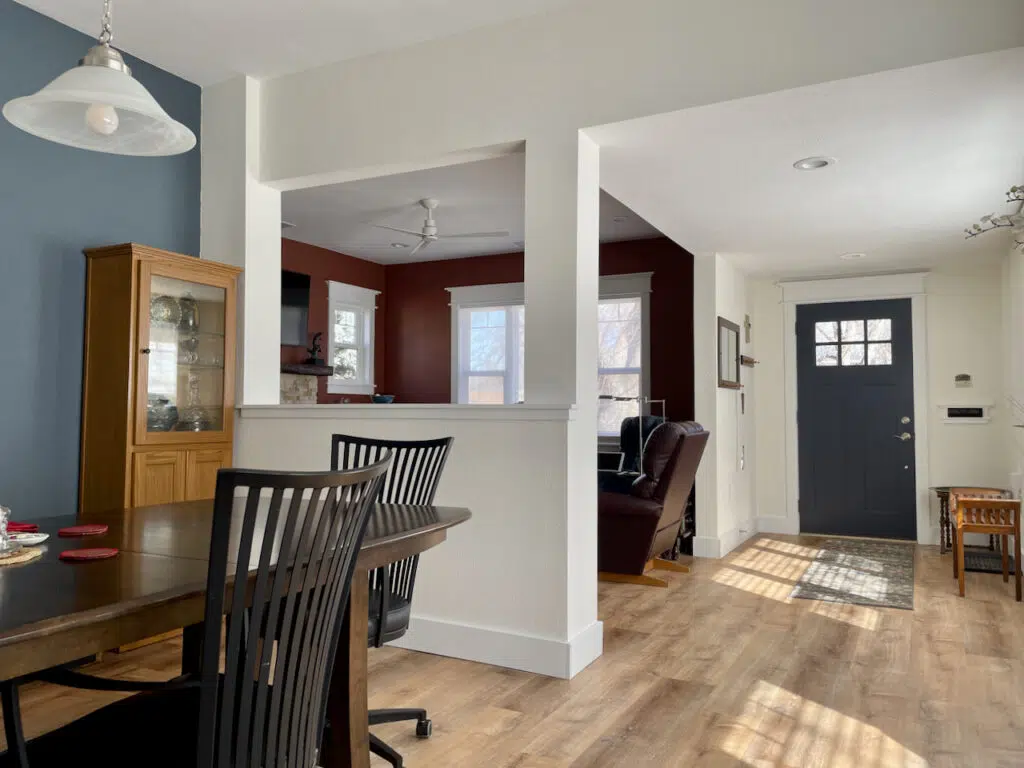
[282,154,660,264]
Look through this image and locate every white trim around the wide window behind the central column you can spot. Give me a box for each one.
[444,272,654,411]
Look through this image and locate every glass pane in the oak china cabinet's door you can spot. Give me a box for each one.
[145,274,225,432]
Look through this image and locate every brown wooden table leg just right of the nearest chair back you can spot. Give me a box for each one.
[321,568,370,768]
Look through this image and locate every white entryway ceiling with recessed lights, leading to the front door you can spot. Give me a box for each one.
[588,48,1024,276]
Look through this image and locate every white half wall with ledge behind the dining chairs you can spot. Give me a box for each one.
[236,406,602,678]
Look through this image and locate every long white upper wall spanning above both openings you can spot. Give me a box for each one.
[256,0,1024,189]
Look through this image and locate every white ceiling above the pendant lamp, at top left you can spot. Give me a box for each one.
[17,0,570,87]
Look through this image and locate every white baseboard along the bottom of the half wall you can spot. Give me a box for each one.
[391,616,604,679]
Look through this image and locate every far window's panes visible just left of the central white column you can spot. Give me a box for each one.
[458,304,525,406]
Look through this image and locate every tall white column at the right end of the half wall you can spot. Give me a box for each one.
[524,131,602,674]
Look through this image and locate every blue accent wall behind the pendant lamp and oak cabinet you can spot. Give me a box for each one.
[0,0,202,520]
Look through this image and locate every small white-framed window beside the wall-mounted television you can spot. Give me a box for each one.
[327,283,379,394]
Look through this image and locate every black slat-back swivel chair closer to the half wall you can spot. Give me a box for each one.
[331,434,455,768]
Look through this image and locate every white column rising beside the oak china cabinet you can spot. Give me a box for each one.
[200,77,281,406]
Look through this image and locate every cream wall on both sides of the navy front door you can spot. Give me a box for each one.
[751,257,1010,543]
